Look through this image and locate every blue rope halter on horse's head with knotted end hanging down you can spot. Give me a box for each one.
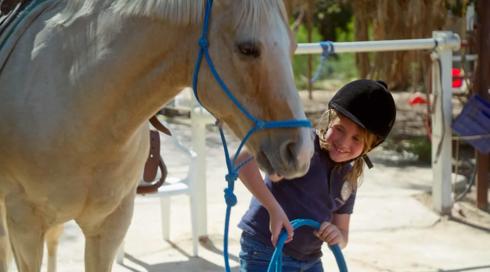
[192,0,311,271]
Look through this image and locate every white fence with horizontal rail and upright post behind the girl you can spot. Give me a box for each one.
[295,31,460,214]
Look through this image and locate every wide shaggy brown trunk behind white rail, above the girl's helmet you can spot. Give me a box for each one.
[353,0,446,89]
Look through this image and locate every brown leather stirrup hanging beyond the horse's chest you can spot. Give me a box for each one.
[136,116,172,194]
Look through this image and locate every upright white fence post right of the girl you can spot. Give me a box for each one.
[431,31,460,214]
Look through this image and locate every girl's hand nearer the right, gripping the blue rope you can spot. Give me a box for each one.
[314,214,350,248]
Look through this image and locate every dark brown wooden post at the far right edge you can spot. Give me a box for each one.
[474,1,490,210]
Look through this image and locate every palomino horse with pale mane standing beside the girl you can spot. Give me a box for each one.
[0,0,313,272]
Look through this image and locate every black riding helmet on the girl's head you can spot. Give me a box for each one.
[328,79,396,167]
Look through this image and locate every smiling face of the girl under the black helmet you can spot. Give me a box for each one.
[324,115,365,163]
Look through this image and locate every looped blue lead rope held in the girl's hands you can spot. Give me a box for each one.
[267,219,347,272]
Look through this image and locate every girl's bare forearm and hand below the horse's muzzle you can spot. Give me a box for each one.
[236,150,293,246]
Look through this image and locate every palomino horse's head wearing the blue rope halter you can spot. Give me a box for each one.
[192,0,313,178]
